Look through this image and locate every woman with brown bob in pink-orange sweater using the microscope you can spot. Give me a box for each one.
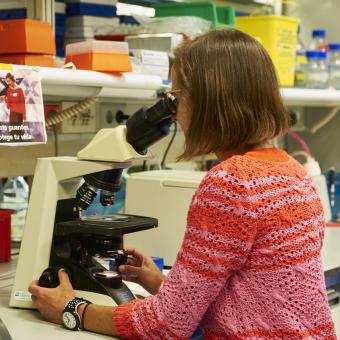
[29,30,336,340]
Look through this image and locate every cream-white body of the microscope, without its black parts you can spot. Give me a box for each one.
[10,126,149,308]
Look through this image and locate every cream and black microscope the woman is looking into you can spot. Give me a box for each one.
[10,91,176,308]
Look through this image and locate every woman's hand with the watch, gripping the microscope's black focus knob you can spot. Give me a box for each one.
[28,269,75,324]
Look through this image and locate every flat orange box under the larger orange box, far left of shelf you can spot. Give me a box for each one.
[0,54,55,67]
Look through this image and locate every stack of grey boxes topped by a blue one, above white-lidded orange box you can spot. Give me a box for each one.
[65,0,119,44]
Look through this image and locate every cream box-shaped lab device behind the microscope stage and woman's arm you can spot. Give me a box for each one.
[124,170,206,266]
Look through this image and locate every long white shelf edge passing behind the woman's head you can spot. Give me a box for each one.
[16,66,340,107]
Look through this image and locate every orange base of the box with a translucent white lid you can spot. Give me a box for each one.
[66,52,132,72]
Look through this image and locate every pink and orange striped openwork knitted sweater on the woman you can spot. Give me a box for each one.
[113,148,336,340]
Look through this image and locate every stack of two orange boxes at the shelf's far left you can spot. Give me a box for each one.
[0,19,55,67]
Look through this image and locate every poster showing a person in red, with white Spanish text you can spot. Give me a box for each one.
[0,64,47,146]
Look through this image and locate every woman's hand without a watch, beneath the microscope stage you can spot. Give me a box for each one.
[118,248,165,295]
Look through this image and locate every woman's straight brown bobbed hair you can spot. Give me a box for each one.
[173,29,289,159]
